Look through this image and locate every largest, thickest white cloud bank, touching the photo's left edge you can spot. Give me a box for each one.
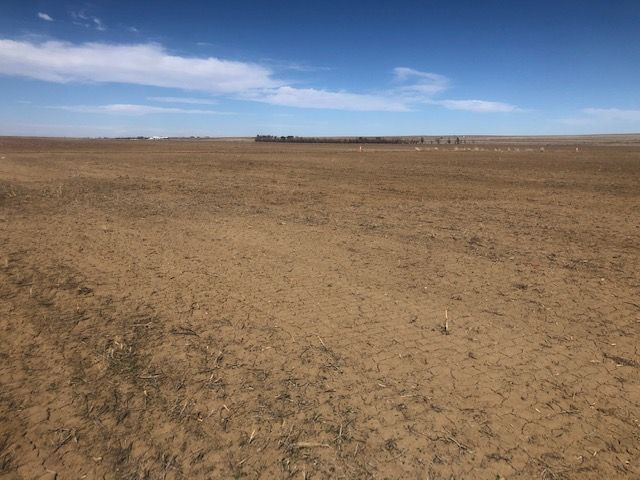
[0,40,280,93]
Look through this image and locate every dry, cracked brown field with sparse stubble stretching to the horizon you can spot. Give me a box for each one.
[0,138,640,480]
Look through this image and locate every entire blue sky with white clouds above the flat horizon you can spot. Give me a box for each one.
[0,0,640,136]
